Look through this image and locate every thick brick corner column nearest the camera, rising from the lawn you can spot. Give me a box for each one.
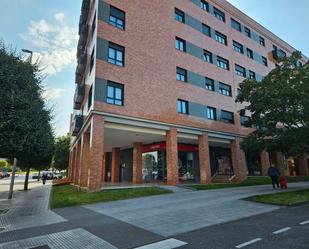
[87,115,104,191]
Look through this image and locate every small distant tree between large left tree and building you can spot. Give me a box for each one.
[53,135,71,171]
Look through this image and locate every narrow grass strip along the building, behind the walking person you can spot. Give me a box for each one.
[188,176,309,190]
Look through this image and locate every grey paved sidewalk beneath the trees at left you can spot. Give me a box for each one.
[0,182,66,233]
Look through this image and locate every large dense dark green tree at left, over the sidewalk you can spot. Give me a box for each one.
[0,42,54,190]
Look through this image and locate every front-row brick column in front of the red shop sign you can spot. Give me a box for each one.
[166,127,179,185]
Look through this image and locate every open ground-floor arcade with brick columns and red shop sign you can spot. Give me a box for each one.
[69,113,306,191]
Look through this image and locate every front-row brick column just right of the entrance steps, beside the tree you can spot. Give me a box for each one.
[231,137,247,181]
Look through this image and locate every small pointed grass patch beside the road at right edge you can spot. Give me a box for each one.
[246,189,309,206]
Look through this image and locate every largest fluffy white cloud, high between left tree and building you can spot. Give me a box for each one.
[20,12,78,75]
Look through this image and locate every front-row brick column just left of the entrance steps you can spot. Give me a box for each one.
[198,133,211,183]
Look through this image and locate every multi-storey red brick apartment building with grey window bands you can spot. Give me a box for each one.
[69,0,309,190]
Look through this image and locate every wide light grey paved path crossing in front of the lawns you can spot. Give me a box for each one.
[84,182,309,236]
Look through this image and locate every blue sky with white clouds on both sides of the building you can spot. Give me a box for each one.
[0,0,309,136]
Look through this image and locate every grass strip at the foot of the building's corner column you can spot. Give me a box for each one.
[51,185,171,208]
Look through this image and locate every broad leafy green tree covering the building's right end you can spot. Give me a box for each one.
[236,52,309,156]
